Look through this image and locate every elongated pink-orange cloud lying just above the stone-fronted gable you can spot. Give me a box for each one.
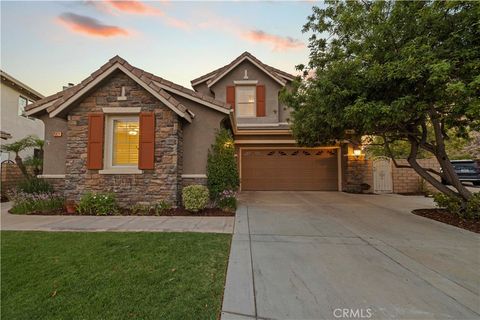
[58,12,129,38]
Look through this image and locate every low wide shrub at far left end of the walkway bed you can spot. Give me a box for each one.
[9,191,65,214]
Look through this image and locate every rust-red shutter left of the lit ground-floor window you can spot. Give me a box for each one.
[87,113,104,170]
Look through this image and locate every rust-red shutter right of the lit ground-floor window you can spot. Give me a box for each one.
[138,112,155,170]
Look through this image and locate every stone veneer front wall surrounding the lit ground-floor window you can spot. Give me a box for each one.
[65,72,182,206]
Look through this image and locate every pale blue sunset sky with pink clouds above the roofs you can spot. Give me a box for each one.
[0,1,314,95]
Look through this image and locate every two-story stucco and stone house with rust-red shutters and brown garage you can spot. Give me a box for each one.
[27,52,356,204]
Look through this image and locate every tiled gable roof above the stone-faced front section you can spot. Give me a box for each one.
[26,56,230,122]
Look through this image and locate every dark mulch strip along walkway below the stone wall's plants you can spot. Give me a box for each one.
[13,208,235,217]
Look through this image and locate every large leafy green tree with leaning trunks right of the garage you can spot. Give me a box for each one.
[282,1,480,208]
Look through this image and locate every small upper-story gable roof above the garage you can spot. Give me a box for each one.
[190,51,295,87]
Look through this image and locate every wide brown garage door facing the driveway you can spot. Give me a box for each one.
[241,149,338,190]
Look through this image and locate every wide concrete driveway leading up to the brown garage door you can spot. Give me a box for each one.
[222,192,480,319]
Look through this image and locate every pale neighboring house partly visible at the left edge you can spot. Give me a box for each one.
[0,71,44,162]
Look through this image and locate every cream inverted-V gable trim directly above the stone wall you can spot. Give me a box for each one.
[50,62,192,122]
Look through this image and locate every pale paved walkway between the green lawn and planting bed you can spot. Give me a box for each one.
[0,202,234,233]
